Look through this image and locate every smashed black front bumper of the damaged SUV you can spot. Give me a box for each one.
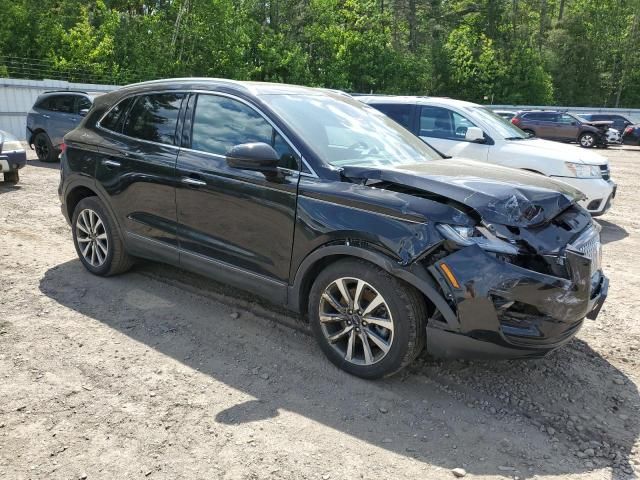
[427,246,609,358]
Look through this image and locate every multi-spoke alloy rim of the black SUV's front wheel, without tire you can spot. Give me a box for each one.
[319,277,394,365]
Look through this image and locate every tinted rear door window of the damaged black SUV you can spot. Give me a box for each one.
[123,93,184,145]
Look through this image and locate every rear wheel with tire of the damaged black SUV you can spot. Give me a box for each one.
[71,197,133,276]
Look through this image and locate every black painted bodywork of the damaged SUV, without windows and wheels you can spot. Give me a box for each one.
[59,80,607,357]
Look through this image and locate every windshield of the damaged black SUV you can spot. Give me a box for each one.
[260,92,442,167]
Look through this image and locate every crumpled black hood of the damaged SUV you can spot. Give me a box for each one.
[342,159,584,227]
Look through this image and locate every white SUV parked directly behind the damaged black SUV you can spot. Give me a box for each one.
[357,96,616,215]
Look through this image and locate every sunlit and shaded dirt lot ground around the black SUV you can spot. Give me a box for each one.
[0,149,640,480]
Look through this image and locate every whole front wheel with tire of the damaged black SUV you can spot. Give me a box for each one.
[309,259,426,379]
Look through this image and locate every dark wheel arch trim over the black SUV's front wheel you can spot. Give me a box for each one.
[287,246,459,329]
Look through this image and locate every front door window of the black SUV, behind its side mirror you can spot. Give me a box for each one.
[191,95,298,170]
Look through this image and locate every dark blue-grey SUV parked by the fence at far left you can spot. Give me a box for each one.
[26,90,94,162]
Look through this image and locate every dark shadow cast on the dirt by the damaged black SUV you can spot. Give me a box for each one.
[39,260,640,479]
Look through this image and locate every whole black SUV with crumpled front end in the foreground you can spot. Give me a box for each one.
[59,79,608,378]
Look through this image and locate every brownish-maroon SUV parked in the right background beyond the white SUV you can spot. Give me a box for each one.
[511,110,613,148]
